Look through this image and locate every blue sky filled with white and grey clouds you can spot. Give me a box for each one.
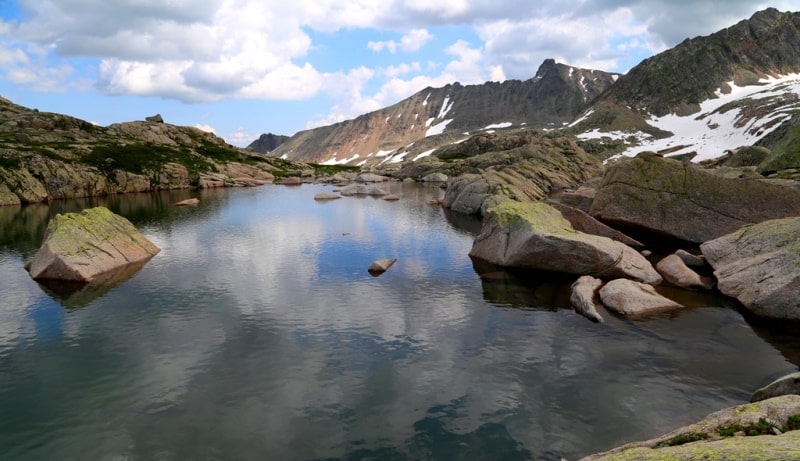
[0,0,800,146]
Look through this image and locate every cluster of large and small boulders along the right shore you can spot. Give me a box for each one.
[456,153,800,322]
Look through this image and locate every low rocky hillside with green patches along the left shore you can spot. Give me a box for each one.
[0,98,300,205]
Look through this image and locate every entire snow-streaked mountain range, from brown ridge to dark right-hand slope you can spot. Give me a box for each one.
[251,8,800,167]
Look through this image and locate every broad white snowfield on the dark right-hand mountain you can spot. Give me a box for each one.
[588,74,800,162]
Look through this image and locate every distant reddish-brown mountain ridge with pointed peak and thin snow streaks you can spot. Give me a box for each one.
[270,59,618,164]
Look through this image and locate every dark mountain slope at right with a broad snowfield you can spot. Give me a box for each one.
[572,8,800,164]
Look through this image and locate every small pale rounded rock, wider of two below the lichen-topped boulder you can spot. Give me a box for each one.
[600,279,683,316]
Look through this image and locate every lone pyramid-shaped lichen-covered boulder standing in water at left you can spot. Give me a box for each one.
[25,207,160,283]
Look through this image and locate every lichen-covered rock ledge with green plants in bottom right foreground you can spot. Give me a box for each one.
[581,395,800,461]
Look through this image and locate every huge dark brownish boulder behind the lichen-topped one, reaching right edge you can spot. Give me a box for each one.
[590,153,800,243]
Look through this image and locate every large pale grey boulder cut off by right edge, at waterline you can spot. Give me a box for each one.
[700,217,800,319]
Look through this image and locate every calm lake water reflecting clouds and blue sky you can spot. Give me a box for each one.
[0,183,800,460]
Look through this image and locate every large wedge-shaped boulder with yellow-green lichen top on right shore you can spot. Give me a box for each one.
[470,200,662,284]
